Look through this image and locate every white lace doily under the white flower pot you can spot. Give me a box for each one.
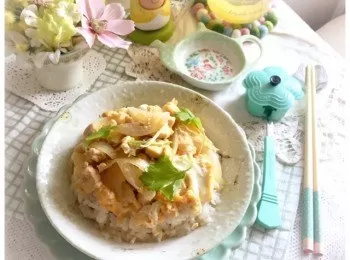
[5,50,106,111]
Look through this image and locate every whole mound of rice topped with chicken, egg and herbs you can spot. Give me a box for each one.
[71,99,222,243]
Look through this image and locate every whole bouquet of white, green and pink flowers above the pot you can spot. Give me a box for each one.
[5,0,134,67]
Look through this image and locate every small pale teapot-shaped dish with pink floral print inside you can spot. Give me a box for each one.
[151,23,263,91]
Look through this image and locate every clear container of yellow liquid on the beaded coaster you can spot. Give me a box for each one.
[207,0,271,24]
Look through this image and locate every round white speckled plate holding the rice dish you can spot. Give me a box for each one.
[36,81,254,260]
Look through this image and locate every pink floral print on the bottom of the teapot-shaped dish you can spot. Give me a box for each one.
[185,49,235,82]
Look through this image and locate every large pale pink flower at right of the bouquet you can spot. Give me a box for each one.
[76,0,135,49]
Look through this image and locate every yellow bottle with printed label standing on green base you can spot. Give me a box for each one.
[130,0,171,31]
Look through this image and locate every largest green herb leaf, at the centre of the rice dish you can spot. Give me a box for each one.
[140,156,186,200]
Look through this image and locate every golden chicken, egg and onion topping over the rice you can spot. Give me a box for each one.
[71,99,222,239]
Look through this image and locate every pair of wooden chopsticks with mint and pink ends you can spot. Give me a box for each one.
[302,66,322,255]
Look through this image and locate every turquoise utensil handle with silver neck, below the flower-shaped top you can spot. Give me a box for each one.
[256,122,281,229]
